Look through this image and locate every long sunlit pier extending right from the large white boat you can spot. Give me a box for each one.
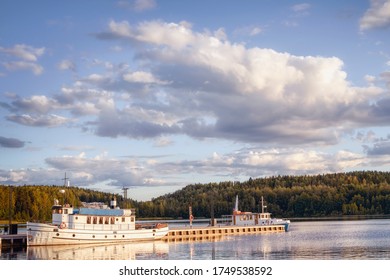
[162,225,286,241]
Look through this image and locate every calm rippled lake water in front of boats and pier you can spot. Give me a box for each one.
[0,219,390,260]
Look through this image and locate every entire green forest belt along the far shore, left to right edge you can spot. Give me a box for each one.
[0,171,390,221]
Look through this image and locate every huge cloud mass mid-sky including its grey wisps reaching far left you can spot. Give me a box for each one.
[2,20,390,144]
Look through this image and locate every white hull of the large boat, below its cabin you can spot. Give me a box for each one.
[27,223,168,246]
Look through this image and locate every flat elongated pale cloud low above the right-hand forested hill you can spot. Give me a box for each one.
[147,147,369,178]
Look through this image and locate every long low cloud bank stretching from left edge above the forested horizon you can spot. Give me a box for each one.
[0,147,371,189]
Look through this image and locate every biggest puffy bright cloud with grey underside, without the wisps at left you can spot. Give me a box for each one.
[93,20,388,143]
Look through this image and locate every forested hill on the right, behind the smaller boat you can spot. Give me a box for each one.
[139,171,390,218]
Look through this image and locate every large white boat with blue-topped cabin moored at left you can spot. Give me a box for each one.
[27,199,168,246]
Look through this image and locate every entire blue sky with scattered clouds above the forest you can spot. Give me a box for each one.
[0,0,390,200]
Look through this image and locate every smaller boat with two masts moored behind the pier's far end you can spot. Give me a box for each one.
[223,196,290,231]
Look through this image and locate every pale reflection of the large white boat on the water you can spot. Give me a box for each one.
[27,241,169,260]
